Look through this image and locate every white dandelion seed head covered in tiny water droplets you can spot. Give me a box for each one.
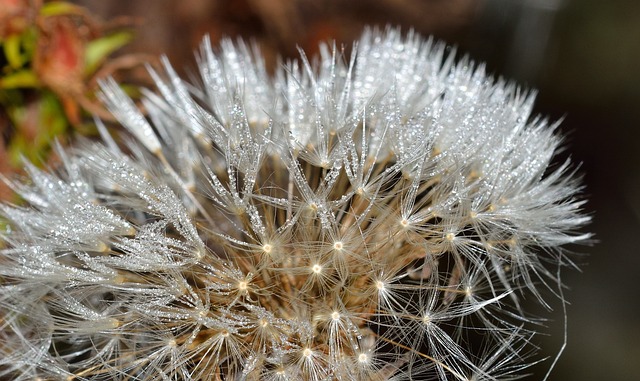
[0,28,589,381]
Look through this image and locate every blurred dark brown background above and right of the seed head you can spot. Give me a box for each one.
[0,0,640,381]
